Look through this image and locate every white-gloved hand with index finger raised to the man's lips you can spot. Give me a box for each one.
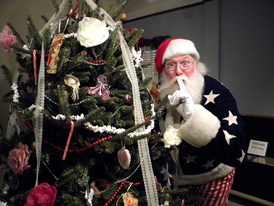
[168,77,195,121]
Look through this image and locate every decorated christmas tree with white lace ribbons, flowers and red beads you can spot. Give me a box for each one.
[0,0,186,205]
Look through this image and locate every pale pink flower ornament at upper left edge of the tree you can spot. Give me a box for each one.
[0,25,18,53]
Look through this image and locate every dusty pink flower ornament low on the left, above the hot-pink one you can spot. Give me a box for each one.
[7,142,30,174]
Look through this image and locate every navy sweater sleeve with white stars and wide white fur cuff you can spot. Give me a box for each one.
[178,78,247,167]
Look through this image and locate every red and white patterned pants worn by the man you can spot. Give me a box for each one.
[184,170,235,206]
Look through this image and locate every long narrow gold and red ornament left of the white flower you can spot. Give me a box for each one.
[46,34,64,74]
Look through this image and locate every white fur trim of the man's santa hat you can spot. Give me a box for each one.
[162,39,200,64]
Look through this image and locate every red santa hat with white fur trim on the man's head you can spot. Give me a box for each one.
[155,38,200,73]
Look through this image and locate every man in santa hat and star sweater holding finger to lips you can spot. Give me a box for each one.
[155,38,247,206]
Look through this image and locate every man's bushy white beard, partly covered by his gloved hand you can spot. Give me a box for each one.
[159,63,206,104]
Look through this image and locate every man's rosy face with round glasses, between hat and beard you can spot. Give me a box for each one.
[164,54,197,79]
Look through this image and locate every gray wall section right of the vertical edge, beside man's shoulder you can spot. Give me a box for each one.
[220,0,274,116]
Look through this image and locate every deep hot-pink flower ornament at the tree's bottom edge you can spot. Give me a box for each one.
[26,182,57,206]
